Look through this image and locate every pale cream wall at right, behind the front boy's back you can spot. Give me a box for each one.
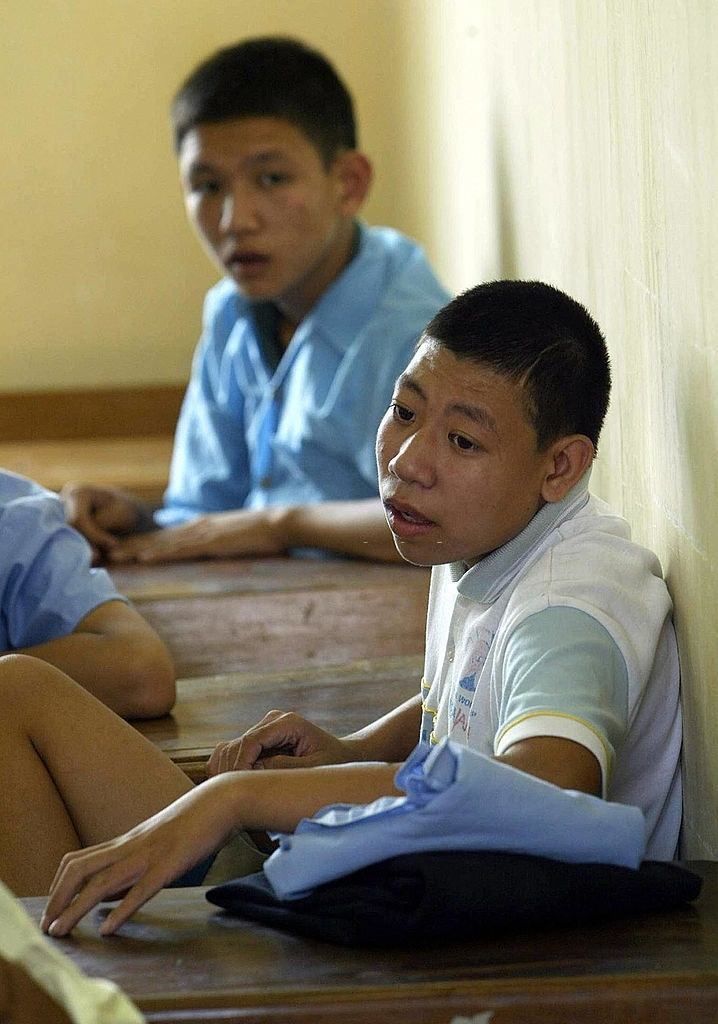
[407,0,718,858]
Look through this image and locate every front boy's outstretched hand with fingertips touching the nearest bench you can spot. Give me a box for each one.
[40,779,234,937]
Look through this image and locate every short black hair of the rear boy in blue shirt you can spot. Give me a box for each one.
[171,36,356,166]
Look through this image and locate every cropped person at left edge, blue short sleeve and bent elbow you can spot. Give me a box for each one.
[0,470,175,718]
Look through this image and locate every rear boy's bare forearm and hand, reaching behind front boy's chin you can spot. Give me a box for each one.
[108,498,400,562]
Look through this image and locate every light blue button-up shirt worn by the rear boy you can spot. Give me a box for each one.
[156,225,448,525]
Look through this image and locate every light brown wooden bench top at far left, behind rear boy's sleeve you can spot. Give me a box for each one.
[0,434,172,504]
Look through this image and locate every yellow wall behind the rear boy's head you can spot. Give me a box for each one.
[0,0,428,391]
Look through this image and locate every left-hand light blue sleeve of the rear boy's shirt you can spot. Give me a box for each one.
[155,282,249,526]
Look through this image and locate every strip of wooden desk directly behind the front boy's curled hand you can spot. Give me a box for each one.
[134,655,422,781]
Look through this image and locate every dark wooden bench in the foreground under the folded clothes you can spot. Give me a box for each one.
[23,862,718,1024]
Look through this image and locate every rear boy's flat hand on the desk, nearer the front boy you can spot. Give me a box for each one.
[108,509,285,563]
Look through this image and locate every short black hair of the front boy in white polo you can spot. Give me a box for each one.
[423,281,610,451]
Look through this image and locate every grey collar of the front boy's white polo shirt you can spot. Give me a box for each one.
[449,469,591,604]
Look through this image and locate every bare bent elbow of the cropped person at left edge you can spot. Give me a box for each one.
[16,601,175,718]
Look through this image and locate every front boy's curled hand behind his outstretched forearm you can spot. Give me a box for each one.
[207,711,358,775]
